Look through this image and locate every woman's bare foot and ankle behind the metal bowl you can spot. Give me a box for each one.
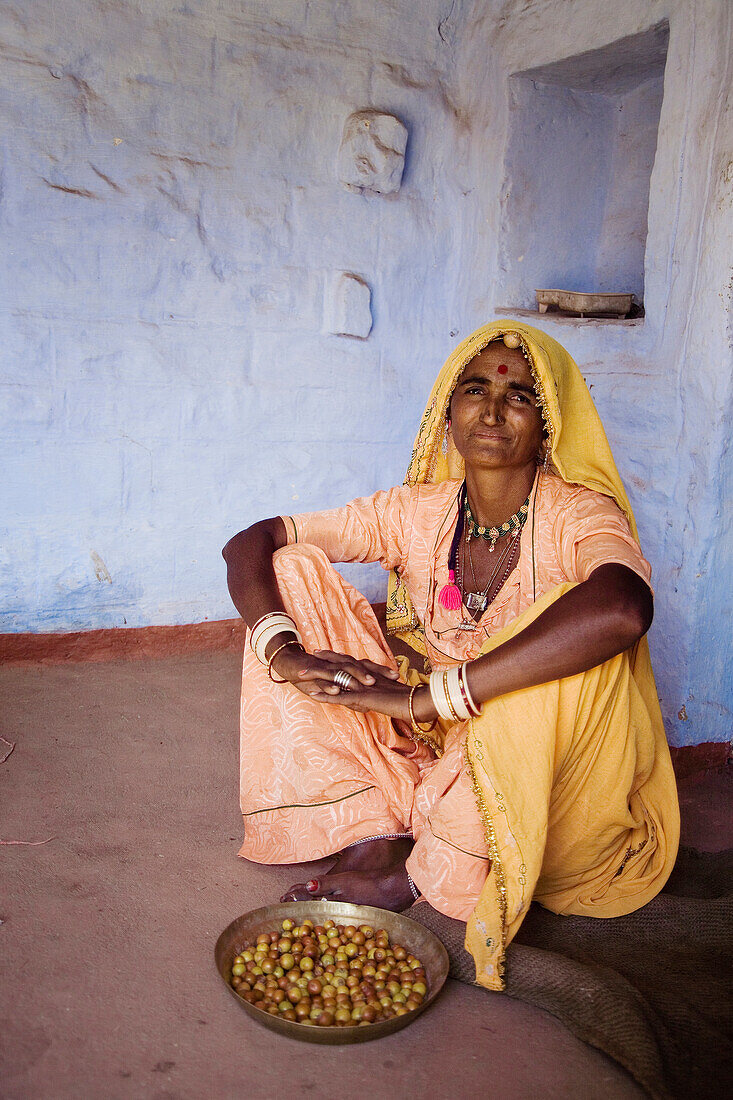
[280,837,415,913]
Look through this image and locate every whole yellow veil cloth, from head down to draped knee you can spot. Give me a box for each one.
[386,320,679,989]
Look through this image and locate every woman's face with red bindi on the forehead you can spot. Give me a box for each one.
[450,340,544,469]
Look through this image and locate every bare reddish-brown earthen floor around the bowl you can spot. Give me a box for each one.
[0,653,733,1100]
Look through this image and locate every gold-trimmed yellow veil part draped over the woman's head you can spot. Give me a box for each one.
[386,320,636,634]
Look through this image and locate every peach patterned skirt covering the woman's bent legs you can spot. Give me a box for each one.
[240,536,489,920]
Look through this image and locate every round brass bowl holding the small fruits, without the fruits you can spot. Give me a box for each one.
[214,901,448,1043]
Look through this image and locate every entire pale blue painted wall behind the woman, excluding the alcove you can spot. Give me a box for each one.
[0,0,733,744]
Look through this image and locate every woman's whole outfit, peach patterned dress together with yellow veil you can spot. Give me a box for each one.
[240,321,679,989]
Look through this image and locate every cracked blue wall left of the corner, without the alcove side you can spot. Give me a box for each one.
[0,0,458,631]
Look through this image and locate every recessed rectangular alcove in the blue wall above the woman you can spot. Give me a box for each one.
[496,22,669,310]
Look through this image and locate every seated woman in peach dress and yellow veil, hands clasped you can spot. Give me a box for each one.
[223,321,679,989]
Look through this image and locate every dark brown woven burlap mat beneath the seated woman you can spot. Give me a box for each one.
[408,849,733,1100]
